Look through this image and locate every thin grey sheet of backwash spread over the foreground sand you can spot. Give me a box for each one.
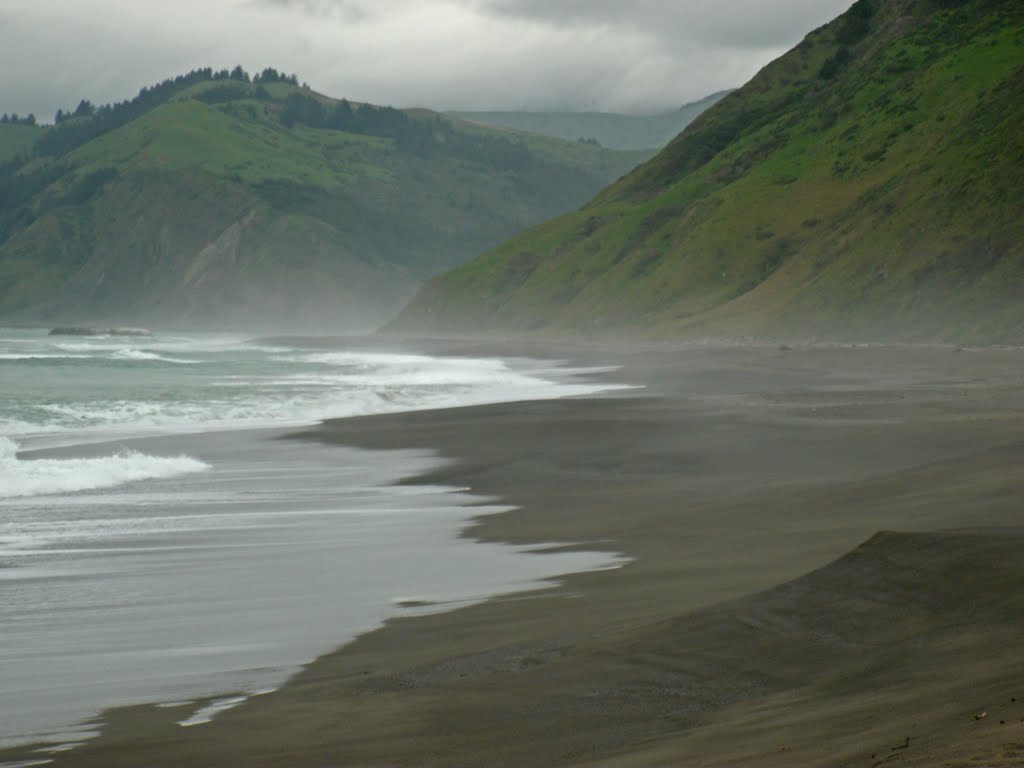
[0,409,616,763]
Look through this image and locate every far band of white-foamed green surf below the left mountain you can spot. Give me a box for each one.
[0,334,634,447]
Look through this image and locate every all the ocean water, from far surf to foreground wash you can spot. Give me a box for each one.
[0,329,623,745]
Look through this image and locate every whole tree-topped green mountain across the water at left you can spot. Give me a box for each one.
[0,68,650,332]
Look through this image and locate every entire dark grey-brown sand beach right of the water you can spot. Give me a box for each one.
[12,342,1024,768]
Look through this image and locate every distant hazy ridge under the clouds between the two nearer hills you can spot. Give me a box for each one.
[449,91,730,150]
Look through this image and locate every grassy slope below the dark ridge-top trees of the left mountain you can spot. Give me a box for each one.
[0,83,649,326]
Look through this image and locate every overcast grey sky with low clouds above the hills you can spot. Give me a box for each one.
[0,0,852,121]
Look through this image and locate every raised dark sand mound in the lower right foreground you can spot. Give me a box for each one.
[600,530,1024,766]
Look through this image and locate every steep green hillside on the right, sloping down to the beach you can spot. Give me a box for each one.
[392,0,1024,341]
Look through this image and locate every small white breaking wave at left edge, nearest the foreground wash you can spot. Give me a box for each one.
[0,437,209,498]
